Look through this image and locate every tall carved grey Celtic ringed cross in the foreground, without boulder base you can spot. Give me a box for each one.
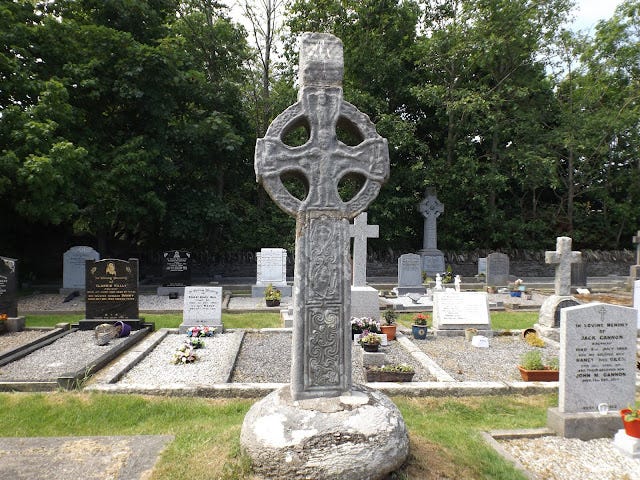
[255,33,389,400]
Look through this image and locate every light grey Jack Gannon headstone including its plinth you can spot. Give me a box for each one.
[548,303,637,440]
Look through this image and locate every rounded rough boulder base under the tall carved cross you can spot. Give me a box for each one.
[240,385,409,480]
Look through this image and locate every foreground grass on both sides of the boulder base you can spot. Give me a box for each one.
[0,392,556,480]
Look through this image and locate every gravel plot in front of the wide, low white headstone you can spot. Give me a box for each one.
[413,335,559,382]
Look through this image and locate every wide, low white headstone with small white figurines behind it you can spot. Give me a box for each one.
[432,290,491,336]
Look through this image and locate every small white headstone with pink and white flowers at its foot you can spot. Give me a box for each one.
[180,287,223,333]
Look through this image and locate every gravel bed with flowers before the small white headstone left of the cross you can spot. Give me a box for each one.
[118,331,242,386]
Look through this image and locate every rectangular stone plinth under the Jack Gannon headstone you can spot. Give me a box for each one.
[547,407,622,440]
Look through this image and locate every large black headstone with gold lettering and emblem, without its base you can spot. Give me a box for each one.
[85,258,138,320]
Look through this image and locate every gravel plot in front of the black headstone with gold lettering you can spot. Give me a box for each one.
[0,330,144,382]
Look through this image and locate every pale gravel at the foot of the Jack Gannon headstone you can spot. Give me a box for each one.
[498,436,640,480]
